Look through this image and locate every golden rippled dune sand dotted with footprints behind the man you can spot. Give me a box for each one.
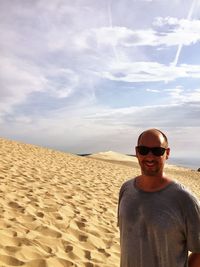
[0,139,200,267]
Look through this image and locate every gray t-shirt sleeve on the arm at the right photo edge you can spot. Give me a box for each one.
[186,196,200,253]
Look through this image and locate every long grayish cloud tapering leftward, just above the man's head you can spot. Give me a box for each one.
[81,100,200,131]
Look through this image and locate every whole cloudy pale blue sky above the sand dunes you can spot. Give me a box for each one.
[0,0,200,163]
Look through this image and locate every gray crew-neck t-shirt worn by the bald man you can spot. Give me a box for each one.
[118,179,200,267]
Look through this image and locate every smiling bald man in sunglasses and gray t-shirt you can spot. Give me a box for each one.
[118,129,200,267]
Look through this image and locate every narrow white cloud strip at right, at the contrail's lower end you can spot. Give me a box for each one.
[97,62,200,82]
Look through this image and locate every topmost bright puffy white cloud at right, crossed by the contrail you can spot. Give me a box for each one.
[75,17,200,52]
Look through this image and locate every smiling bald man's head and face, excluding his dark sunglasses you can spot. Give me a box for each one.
[136,131,170,176]
